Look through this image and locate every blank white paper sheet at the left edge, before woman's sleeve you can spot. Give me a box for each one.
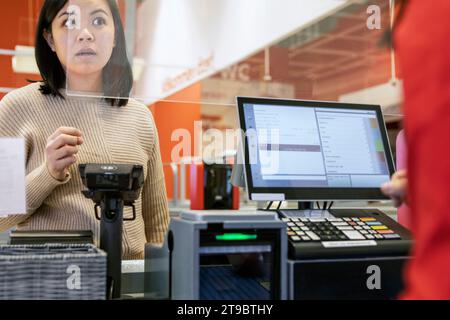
[0,138,26,217]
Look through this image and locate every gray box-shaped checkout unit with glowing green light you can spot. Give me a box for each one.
[145,210,287,300]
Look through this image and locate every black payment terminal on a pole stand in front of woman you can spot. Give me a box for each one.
[79,164,144,299]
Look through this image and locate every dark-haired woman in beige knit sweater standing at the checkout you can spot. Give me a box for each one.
[0,0,169,259]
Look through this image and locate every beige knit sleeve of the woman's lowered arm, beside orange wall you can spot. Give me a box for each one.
[142,110,169,244]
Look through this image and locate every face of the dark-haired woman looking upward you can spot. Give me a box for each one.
[45,0,115,77]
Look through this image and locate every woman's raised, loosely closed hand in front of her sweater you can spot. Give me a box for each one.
[45,127,83,181]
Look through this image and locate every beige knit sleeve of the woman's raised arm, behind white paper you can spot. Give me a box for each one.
[0,91,70,231]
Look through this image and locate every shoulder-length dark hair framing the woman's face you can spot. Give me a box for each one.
[35,0,133,107]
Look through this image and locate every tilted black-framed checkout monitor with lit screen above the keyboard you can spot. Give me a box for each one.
[238,98,393,200]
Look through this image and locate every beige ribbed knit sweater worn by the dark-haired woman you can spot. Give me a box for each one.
[0,83,169,259]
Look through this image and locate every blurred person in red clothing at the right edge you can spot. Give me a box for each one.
[383,0,450,299]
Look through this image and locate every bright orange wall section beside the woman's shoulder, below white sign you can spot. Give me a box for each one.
[150,83,201,199]
